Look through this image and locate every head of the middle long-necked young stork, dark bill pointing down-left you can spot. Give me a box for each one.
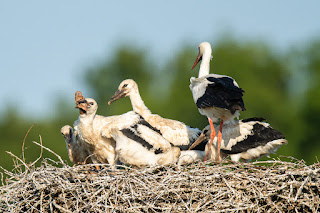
[108,79,138,105]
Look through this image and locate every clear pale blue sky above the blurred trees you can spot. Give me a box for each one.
[0,0,320,118]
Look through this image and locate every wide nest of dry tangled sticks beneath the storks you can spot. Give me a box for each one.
[0,144,320,212]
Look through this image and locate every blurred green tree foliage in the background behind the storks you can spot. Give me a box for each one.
[0,37,320,172]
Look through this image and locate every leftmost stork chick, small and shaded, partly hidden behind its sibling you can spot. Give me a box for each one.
[61,125,92,164]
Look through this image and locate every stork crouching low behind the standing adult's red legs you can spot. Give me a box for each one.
[190,118,288,162]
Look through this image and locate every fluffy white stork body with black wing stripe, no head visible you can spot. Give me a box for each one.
[102,111,180,167]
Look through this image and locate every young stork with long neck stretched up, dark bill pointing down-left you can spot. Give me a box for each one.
[108,79,201,150]
